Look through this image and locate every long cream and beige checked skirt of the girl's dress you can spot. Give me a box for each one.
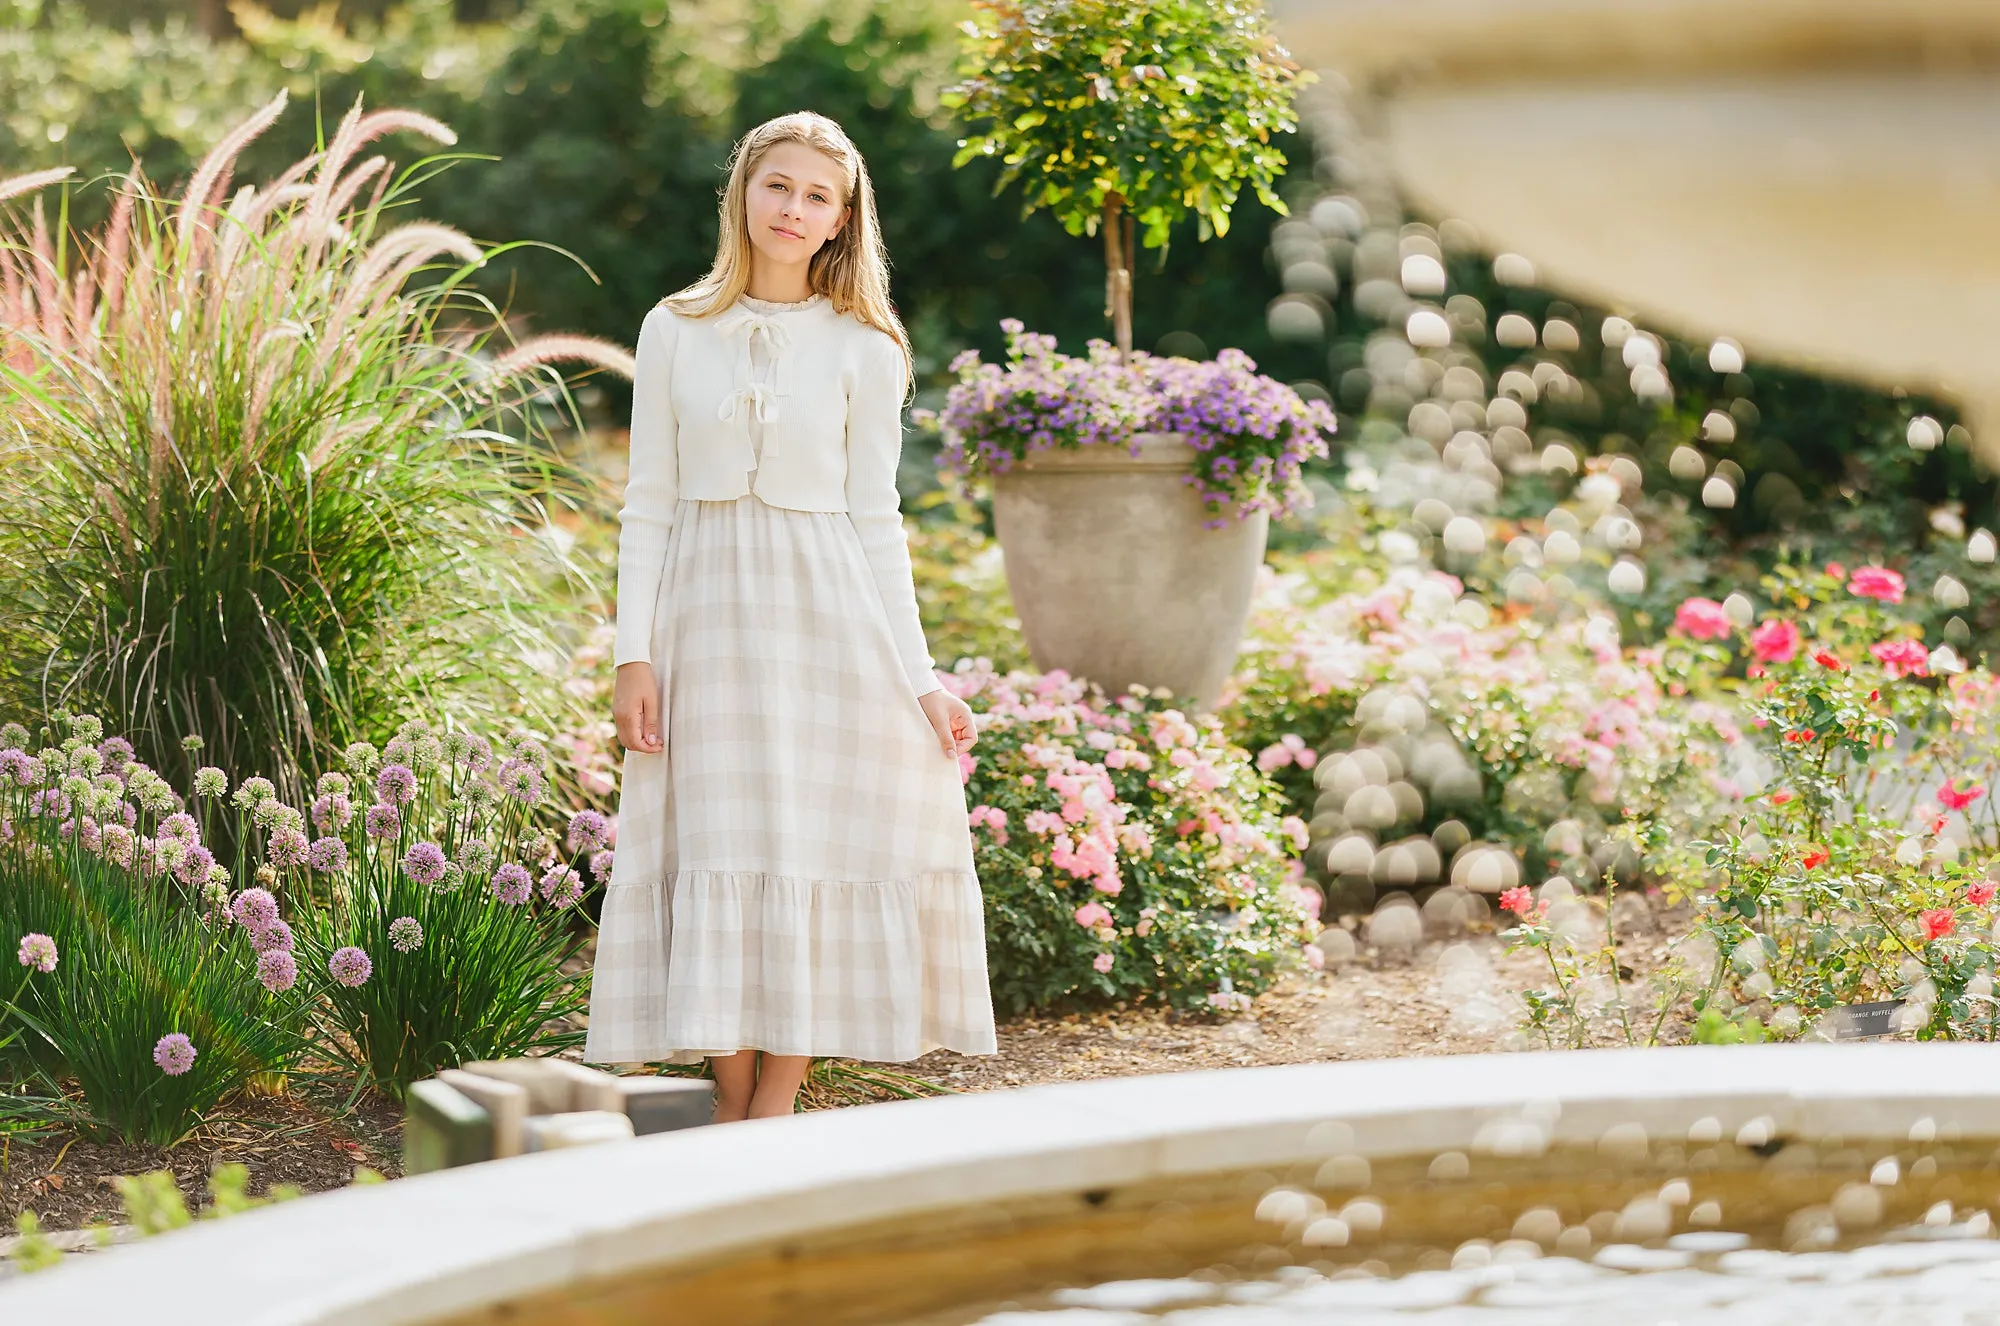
[584,494,996,1064]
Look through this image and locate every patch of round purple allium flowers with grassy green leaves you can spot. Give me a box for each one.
[0,714,610,1146]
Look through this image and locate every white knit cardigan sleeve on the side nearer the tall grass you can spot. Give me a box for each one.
[612,306,680,666]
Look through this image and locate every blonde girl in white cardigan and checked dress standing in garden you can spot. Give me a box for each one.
[584,112,996,1122]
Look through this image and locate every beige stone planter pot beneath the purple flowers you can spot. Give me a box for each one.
[992,434,1270,712]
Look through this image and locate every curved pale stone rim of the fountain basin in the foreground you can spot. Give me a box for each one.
[0,1044,2000,1326]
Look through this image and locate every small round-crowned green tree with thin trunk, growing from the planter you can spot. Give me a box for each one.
[940,0,1312,354]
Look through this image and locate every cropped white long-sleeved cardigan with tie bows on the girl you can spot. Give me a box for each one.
[612,296,942,696]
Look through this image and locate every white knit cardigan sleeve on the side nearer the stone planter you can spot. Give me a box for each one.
[846,328,944,696]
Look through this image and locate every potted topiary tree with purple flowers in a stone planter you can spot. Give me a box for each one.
[942,0,1334,708]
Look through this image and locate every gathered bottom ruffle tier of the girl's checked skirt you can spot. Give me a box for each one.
[584,870,998,1064]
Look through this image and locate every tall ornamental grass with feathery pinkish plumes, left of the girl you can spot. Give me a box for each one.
[0,92,630,796]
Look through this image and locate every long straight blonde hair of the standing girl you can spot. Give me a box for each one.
[660,110,916,390]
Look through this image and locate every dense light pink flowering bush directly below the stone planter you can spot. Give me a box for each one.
[944,660,1318,1012]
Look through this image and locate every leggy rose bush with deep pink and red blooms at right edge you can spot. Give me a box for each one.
[1678,566,2000,1040]
